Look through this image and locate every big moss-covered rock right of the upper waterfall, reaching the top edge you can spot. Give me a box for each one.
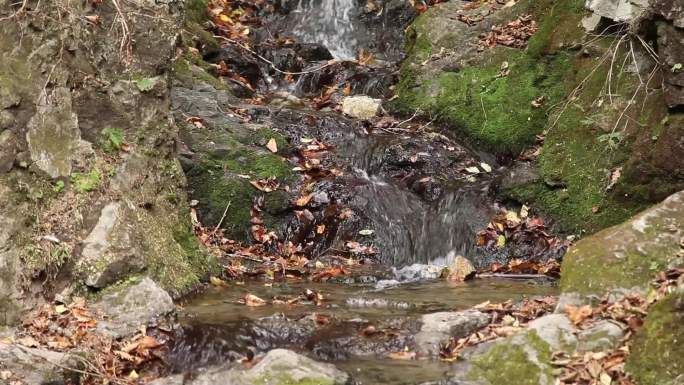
[394,1,582,154]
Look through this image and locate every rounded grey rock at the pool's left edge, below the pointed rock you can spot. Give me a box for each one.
[93,277,175,338]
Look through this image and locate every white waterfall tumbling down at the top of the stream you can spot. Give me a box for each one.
[291,0,360,60]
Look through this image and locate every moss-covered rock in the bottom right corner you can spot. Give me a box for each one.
[625,289,684,385]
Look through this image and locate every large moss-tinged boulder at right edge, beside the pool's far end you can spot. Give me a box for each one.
[561,192,684,295]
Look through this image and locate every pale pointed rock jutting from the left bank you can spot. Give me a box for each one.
[78,202,145,288]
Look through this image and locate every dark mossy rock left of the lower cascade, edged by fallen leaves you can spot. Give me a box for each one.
[186,123,295,240]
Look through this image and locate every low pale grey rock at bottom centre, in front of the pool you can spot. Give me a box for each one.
[151,349,350,385]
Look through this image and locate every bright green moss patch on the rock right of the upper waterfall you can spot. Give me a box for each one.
[434,49,570,154]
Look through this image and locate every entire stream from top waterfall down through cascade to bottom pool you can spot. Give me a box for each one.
[167,0,556,385]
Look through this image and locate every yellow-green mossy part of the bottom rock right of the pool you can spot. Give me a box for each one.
[468,331,552,385]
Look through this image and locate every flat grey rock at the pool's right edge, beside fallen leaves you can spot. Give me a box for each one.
[415,311,491,355]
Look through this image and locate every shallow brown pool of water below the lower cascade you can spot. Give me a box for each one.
[169,279,556,385]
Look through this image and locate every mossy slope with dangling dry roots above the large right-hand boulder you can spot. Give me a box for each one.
[502,39,684,234]
